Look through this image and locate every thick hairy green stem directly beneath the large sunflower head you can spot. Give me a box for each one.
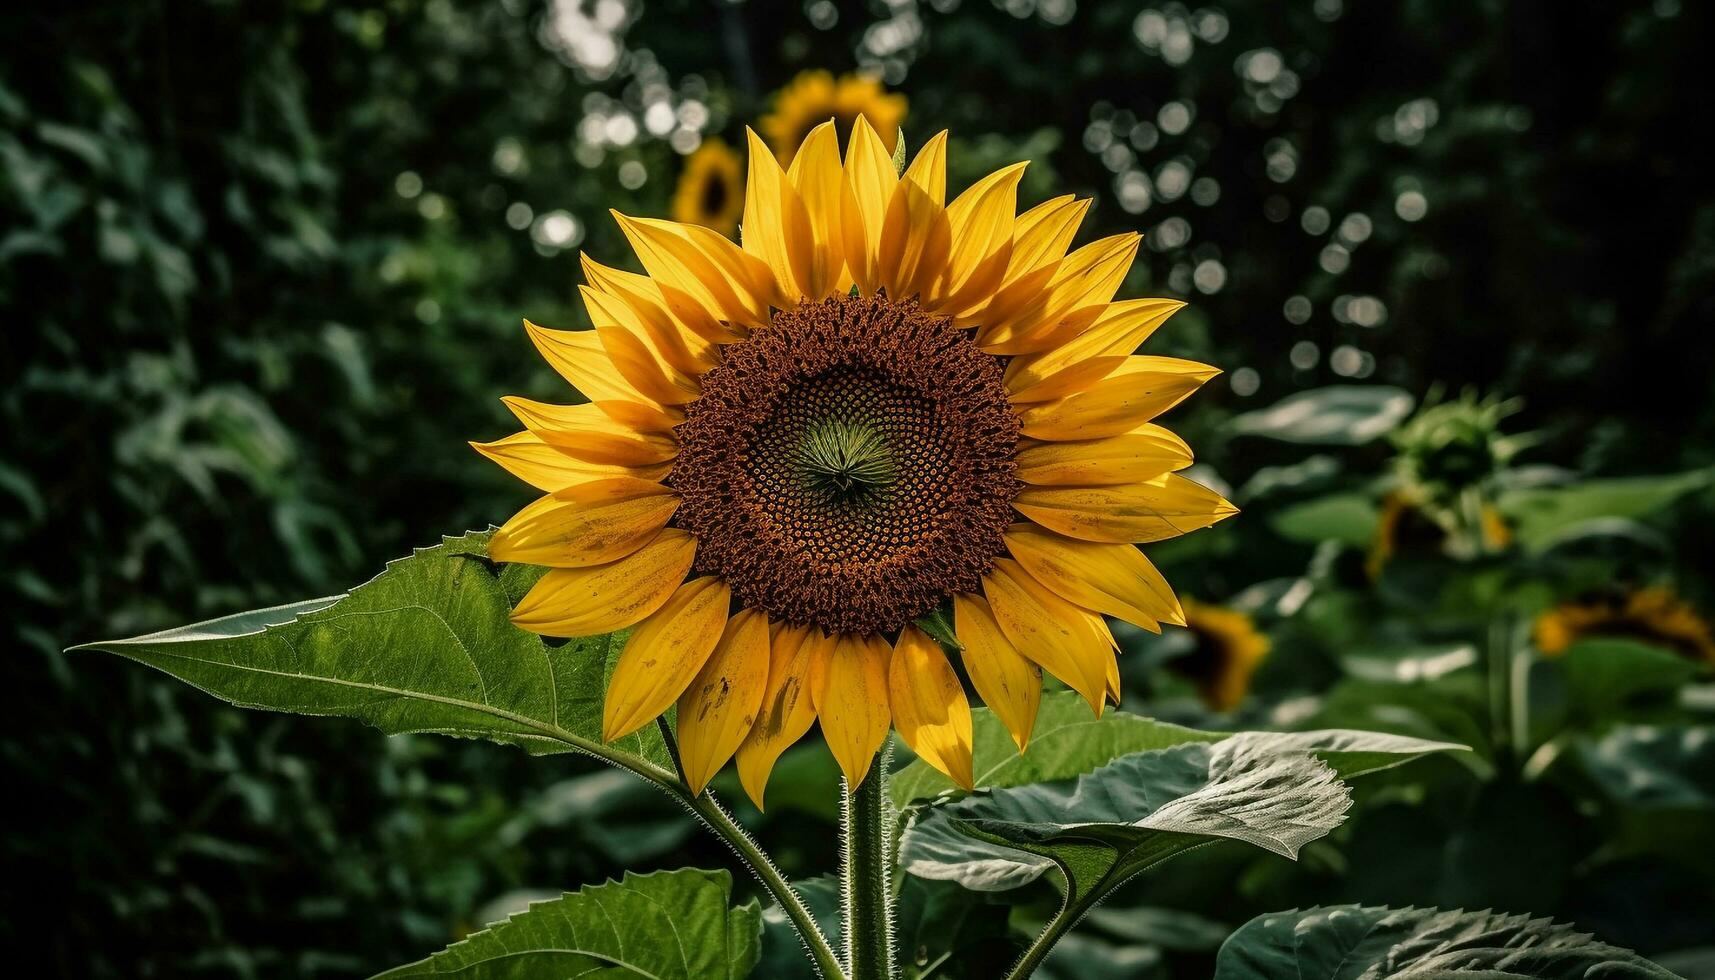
[840,748,894,980]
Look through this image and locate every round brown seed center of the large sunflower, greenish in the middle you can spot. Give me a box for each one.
[667,297,1019,633]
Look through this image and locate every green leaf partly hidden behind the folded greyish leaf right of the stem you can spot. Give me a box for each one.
[888,692,1465,808]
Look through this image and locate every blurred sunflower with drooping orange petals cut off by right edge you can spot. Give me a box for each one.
[1535,587,1715,664]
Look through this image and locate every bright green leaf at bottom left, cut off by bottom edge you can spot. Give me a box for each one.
[376,868,761,980]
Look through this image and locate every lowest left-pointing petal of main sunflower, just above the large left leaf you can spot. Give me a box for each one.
[511,527,696,637]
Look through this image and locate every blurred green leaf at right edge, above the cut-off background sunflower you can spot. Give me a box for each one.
[1495,469,1715,551]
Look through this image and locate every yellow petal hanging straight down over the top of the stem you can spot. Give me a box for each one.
[811,635,892,789]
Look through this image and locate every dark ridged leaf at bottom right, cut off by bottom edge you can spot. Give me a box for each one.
[1214,904,1674,980]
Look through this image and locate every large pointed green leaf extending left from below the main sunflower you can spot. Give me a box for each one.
[72,532,671,772]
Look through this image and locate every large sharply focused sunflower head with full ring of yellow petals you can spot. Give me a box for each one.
[477,118,1235,805]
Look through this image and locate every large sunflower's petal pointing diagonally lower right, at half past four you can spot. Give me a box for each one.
[983,558,1108,717]
